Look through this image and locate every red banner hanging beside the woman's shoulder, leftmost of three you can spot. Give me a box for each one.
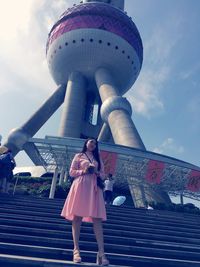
[100,151,117,175]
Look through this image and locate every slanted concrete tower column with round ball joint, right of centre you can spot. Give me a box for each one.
[95,68,145,149]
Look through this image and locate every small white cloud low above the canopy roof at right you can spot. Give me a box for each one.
[153,137,184,155]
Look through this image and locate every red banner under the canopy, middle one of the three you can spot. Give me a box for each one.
[145,160,165,184]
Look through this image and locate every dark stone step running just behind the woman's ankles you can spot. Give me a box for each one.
[0,233,200,260]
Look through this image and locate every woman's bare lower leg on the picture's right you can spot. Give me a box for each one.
[93,218,104,255]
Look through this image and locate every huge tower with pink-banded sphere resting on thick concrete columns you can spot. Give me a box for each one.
[5,0,170,207]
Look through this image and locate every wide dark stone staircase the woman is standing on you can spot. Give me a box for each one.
[0,196,200,267]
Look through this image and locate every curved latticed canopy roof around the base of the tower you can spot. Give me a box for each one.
[23,136,200,199]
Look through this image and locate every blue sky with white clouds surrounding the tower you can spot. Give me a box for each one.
[0,0,200,170]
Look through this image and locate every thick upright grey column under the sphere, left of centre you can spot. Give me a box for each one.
[59,72,86,138]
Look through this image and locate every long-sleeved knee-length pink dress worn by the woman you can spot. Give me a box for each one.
[61,153,106,222]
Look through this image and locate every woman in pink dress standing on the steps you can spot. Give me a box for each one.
[61,138,109,266]
